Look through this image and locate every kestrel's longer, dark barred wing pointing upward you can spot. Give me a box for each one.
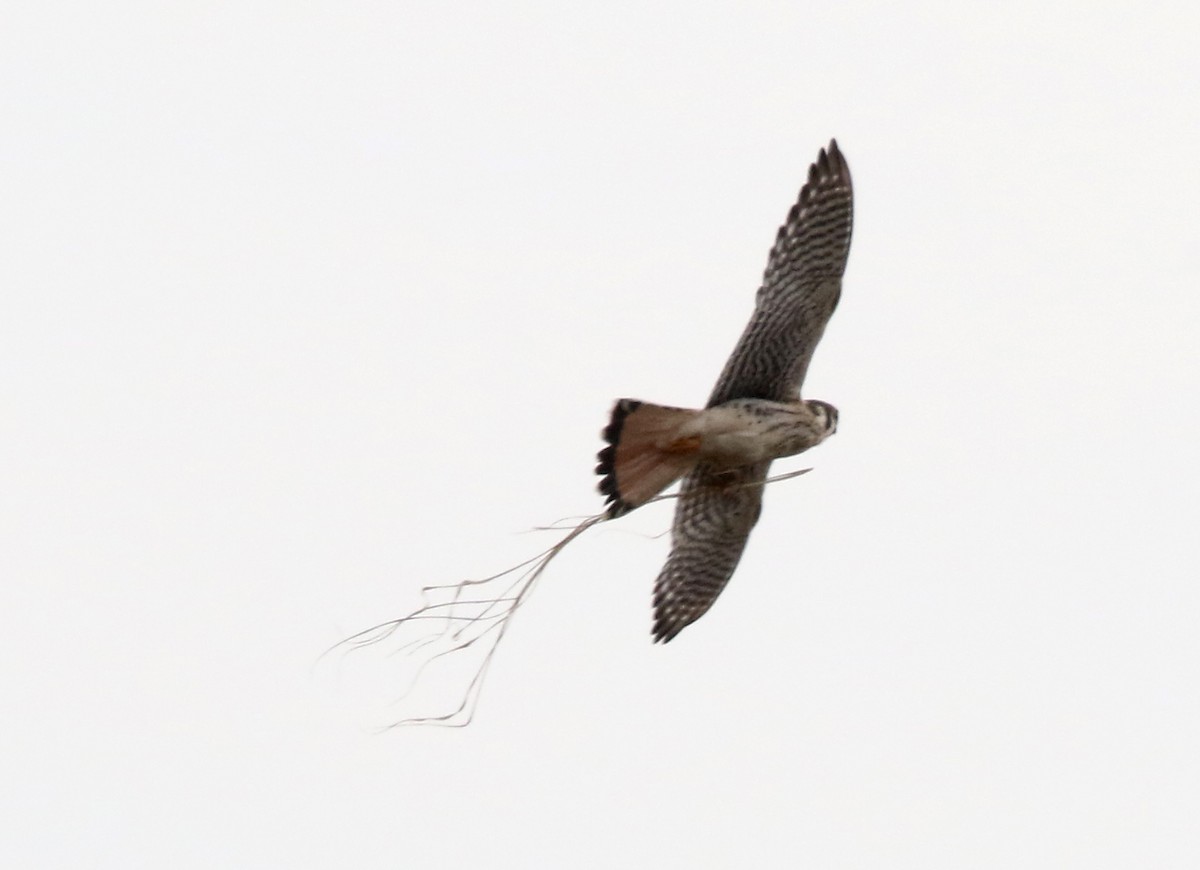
[708,140,854,407]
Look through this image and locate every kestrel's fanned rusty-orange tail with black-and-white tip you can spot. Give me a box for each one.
[596,398,702,517]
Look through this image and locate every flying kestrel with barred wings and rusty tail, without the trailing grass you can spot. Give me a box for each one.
[596,140,853,643]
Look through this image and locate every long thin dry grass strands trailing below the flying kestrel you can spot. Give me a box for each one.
[318,468,812,731]
